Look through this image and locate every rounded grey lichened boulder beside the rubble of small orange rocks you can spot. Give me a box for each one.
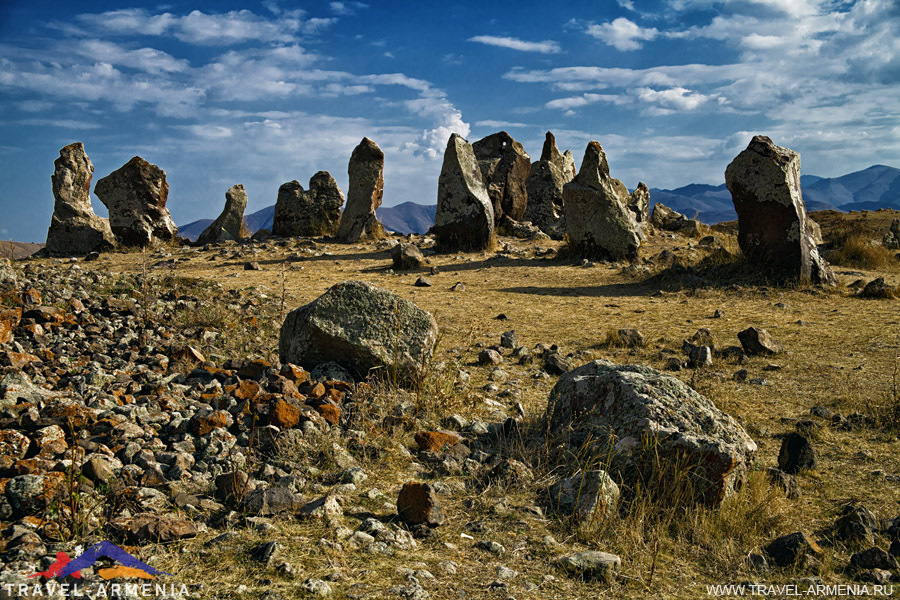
[278,281,438,379]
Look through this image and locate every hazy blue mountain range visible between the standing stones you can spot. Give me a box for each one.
[178,165,900,240]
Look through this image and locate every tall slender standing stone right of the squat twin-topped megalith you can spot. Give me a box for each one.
[338,138,384,242]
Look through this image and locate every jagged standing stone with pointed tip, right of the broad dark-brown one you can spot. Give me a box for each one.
[524,131,575,233]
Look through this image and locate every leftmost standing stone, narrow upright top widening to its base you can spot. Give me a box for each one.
[46,142,116,255]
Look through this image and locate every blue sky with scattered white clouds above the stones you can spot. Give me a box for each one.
[0,0,900,241]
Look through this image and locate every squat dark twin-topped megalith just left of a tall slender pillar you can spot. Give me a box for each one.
[272,171,344,237]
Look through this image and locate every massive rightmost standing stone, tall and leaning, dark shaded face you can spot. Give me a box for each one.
[725,135,836,285]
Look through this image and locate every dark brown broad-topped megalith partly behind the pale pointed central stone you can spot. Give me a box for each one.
[472,131,531,225]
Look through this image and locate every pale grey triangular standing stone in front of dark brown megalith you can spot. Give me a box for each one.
[433,133,495,251]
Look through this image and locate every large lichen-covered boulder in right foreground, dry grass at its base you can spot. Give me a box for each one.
[546,360,756,506]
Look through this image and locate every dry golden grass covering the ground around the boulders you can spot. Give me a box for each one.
[24,215,900,599]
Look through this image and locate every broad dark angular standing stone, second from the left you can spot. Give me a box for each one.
[94,156,178,247]
